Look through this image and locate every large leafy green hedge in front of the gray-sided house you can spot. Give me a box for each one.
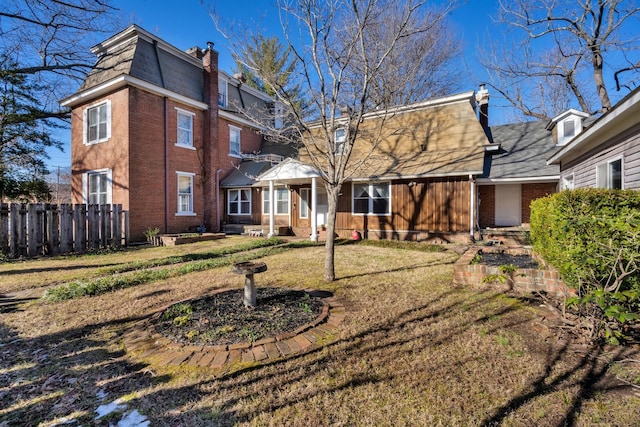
[531,189,640,343]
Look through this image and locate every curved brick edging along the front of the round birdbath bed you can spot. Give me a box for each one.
[122,297,345,369]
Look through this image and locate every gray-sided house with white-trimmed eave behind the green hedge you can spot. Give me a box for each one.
[548,88,640,190]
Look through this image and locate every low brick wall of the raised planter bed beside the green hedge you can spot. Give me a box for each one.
[453,246,572,297]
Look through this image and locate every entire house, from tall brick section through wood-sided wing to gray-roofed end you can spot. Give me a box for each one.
[61,25,564,241]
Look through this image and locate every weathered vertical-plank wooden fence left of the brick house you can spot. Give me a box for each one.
[0,203,129,258]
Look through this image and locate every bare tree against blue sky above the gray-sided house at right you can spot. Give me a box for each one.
[480,0,640,119]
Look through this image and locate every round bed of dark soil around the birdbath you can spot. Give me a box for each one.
[155,287,324,345]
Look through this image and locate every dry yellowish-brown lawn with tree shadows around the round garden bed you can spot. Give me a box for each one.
[0,237,640,427]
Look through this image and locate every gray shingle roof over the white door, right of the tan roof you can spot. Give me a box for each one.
[482,121,560,179]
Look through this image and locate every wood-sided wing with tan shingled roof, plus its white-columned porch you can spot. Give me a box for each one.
[232,91,489,241]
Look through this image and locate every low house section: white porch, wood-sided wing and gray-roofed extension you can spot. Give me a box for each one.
[223,88,564,241]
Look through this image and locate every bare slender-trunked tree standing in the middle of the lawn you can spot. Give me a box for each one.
[219,0,457,281]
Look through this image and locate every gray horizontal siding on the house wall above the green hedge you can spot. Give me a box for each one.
[560,123,640,190]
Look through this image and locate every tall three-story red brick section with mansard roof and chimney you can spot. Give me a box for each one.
[61,25,272,241]
